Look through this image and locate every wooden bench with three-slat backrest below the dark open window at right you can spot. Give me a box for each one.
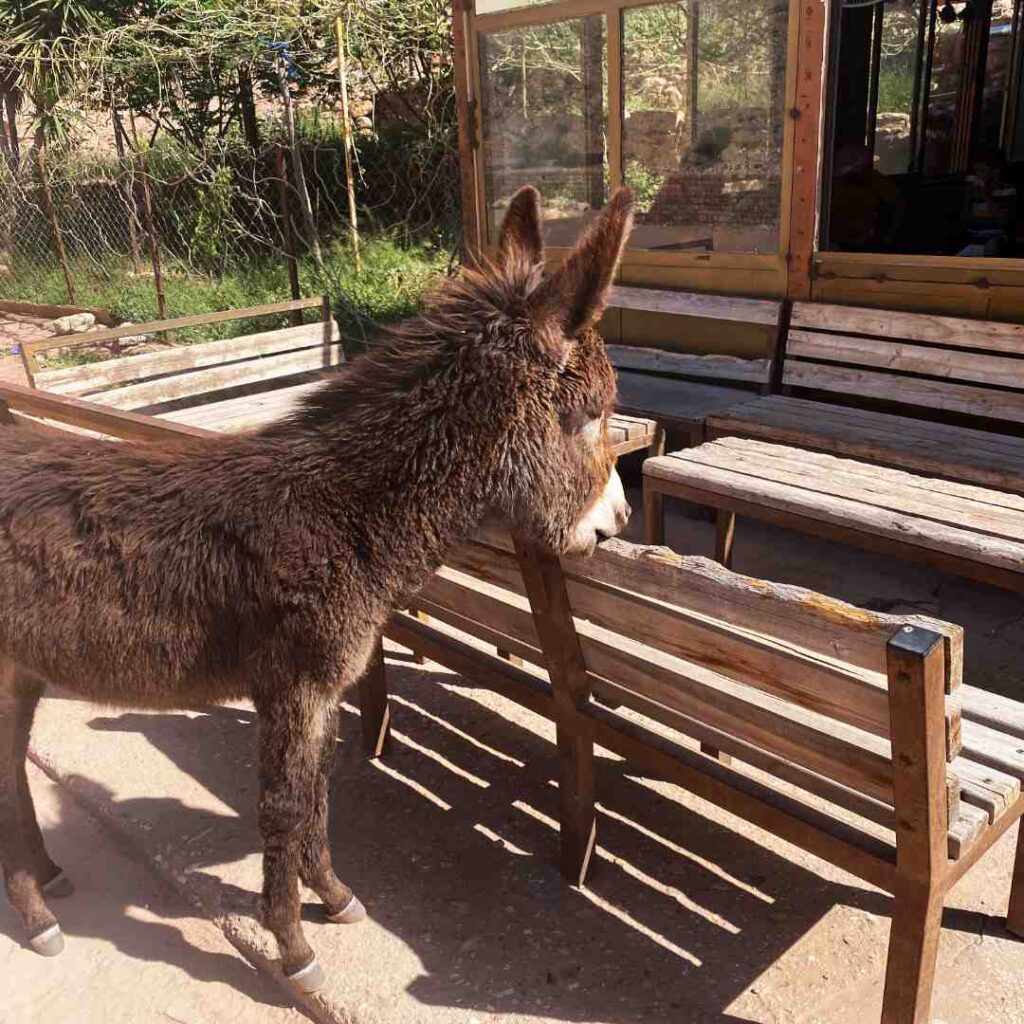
[707,302,1024,494]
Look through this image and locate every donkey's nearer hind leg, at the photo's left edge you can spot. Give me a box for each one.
[0,658,63,956]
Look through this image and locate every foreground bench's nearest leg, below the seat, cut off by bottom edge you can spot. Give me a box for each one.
[882,879,942,1024]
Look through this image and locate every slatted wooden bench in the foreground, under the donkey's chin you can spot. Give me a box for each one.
[359,529,1024,1024]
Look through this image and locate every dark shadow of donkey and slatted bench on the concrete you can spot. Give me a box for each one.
[72,660,999,1024]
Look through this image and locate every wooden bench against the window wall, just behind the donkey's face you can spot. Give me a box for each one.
[605,286,783,444]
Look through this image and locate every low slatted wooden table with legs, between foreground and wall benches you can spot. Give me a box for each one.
[644,437,1024,590]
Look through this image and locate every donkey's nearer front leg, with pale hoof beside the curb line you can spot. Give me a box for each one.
[256,684,334,992]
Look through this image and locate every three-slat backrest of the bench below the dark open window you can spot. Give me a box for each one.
[782,302,1024,429]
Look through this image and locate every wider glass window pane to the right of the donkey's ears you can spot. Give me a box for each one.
[623,0,788,253]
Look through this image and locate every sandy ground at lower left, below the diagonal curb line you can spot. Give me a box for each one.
[0,767,307,1024]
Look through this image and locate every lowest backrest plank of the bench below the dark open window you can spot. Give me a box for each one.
[784,360,1024,423]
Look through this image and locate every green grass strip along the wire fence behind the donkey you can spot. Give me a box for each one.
[0,237,449,366]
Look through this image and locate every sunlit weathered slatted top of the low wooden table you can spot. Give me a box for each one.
[644,438,1024,574]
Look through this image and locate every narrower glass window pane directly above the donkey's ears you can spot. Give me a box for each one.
[478,14,608,246]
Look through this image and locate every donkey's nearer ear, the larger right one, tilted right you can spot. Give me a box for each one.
[530,188,634,336]
